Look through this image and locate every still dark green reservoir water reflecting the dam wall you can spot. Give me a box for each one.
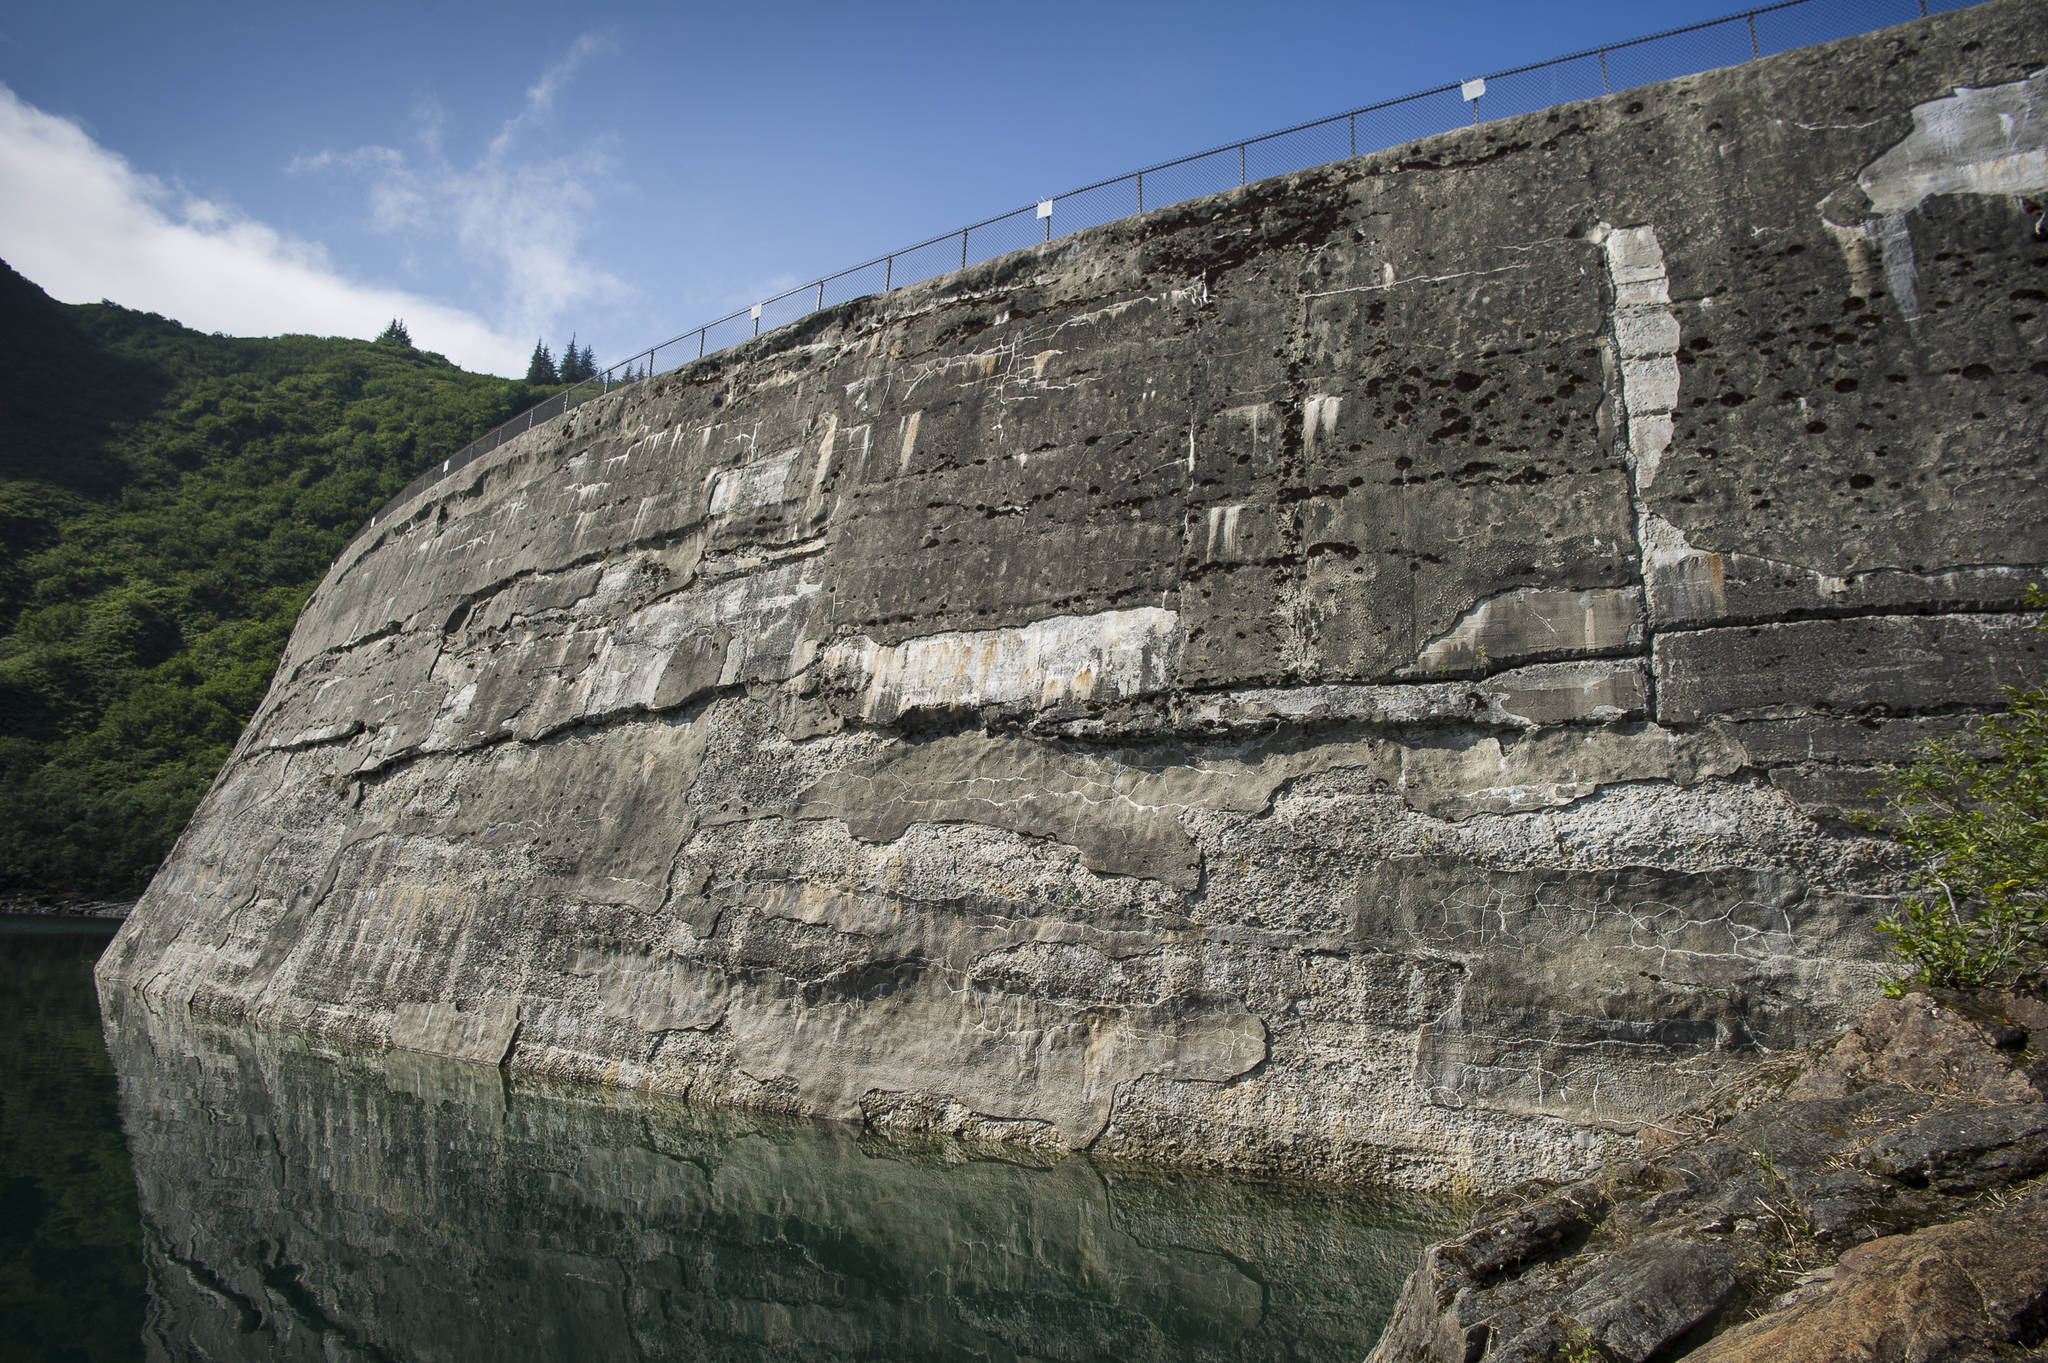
[0,919,1454,1363]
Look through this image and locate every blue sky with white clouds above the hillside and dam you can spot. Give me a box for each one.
[0,0,1911,372]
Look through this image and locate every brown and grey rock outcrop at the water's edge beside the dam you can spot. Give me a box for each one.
[1372,995,2048,1363]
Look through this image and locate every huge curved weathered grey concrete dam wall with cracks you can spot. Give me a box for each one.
[100,0,2048,1187]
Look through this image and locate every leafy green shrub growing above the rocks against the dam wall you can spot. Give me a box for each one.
[1878,587,2048,995]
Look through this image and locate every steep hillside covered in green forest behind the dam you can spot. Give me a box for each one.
[0,264,543,896]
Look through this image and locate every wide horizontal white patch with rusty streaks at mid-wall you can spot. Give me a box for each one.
[823,606,1180,722]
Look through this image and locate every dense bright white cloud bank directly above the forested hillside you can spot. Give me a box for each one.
[0,86,532,375]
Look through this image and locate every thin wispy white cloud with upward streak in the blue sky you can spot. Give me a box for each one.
[309,33,629,350]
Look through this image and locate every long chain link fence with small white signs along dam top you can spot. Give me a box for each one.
[356,0,1978,536]
